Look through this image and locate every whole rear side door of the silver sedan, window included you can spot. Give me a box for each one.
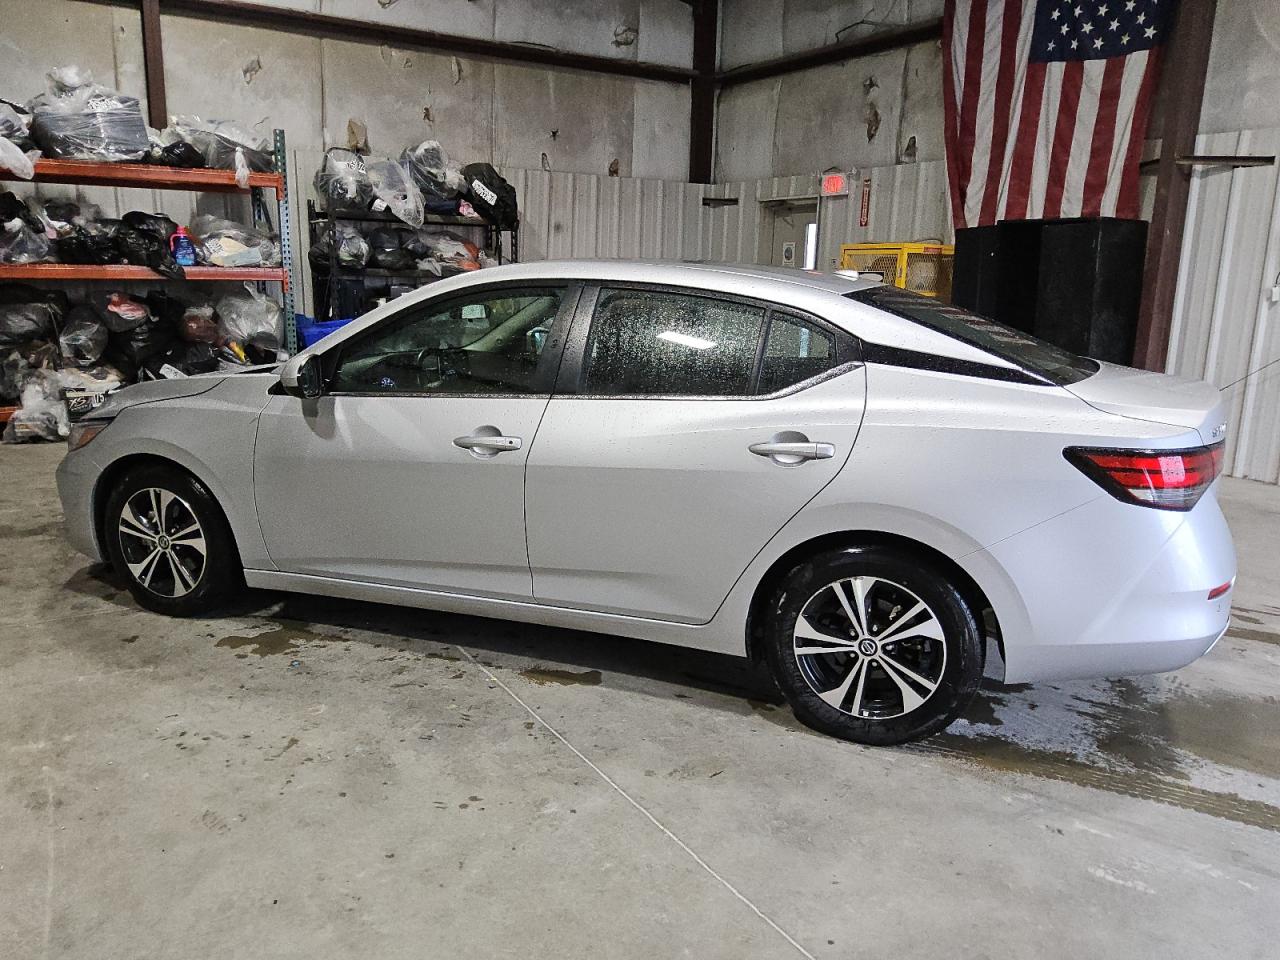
[526,284,865,623]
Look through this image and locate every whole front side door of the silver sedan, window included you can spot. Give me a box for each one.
[255,284,579,600]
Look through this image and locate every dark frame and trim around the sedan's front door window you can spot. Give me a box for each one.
[321,279,582,399]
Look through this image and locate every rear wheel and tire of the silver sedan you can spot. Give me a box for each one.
[764,547,983,746]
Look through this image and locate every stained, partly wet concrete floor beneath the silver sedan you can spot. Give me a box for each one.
[0,445,1280,960]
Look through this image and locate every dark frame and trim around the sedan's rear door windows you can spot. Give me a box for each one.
[553,280,863,401]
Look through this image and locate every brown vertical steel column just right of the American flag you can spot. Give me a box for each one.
[1133,0,1217,371]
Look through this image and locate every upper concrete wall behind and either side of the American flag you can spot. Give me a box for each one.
[716,0,1280,180]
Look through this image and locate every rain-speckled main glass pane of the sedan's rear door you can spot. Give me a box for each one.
[582,289,764,397]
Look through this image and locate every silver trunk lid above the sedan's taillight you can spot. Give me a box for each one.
[1066,362,1226,443]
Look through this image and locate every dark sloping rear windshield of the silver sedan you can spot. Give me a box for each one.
[845,284,1098,387]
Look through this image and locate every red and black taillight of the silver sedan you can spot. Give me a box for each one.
[1062,443,1222,511]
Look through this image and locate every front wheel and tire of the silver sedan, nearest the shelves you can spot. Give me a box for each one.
[102,465,243,617]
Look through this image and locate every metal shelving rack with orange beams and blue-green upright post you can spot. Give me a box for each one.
[0,131,298,422]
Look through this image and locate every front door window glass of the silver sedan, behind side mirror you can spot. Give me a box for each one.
[330,288,564,394]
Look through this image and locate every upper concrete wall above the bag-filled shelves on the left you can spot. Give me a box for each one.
[0,0,692,180]
